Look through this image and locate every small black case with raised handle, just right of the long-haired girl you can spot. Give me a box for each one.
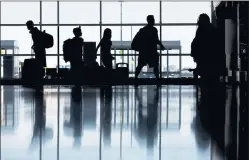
[115,63,129,80]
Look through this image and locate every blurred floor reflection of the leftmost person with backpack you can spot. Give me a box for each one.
[31,91,53,148]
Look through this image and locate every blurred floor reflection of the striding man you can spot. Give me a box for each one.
[135,87,159,149]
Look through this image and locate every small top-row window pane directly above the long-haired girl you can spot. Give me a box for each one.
[102,2,121,24]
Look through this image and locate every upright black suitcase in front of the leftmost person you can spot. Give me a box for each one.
[22,58,36,83]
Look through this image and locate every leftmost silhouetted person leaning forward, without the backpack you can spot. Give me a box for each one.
[26,21,47,83]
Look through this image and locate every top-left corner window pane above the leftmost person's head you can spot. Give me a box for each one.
[1,2,40,24]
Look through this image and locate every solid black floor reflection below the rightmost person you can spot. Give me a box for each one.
[198,78,226,157]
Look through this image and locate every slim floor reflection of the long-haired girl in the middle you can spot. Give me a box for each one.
[101,87,112,146]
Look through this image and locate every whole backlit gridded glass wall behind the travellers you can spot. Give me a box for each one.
[0,1,211,78]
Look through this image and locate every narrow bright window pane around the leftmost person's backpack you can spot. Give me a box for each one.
[42,26,58,54]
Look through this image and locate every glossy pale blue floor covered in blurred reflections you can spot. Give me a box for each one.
[1,86,228,160]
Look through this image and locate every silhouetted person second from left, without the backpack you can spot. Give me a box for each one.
[69,27,84,84]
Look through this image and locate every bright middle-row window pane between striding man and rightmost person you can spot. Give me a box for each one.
[162,26,196,54]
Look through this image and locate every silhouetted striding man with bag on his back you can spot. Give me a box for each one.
[132,15,165,79]
